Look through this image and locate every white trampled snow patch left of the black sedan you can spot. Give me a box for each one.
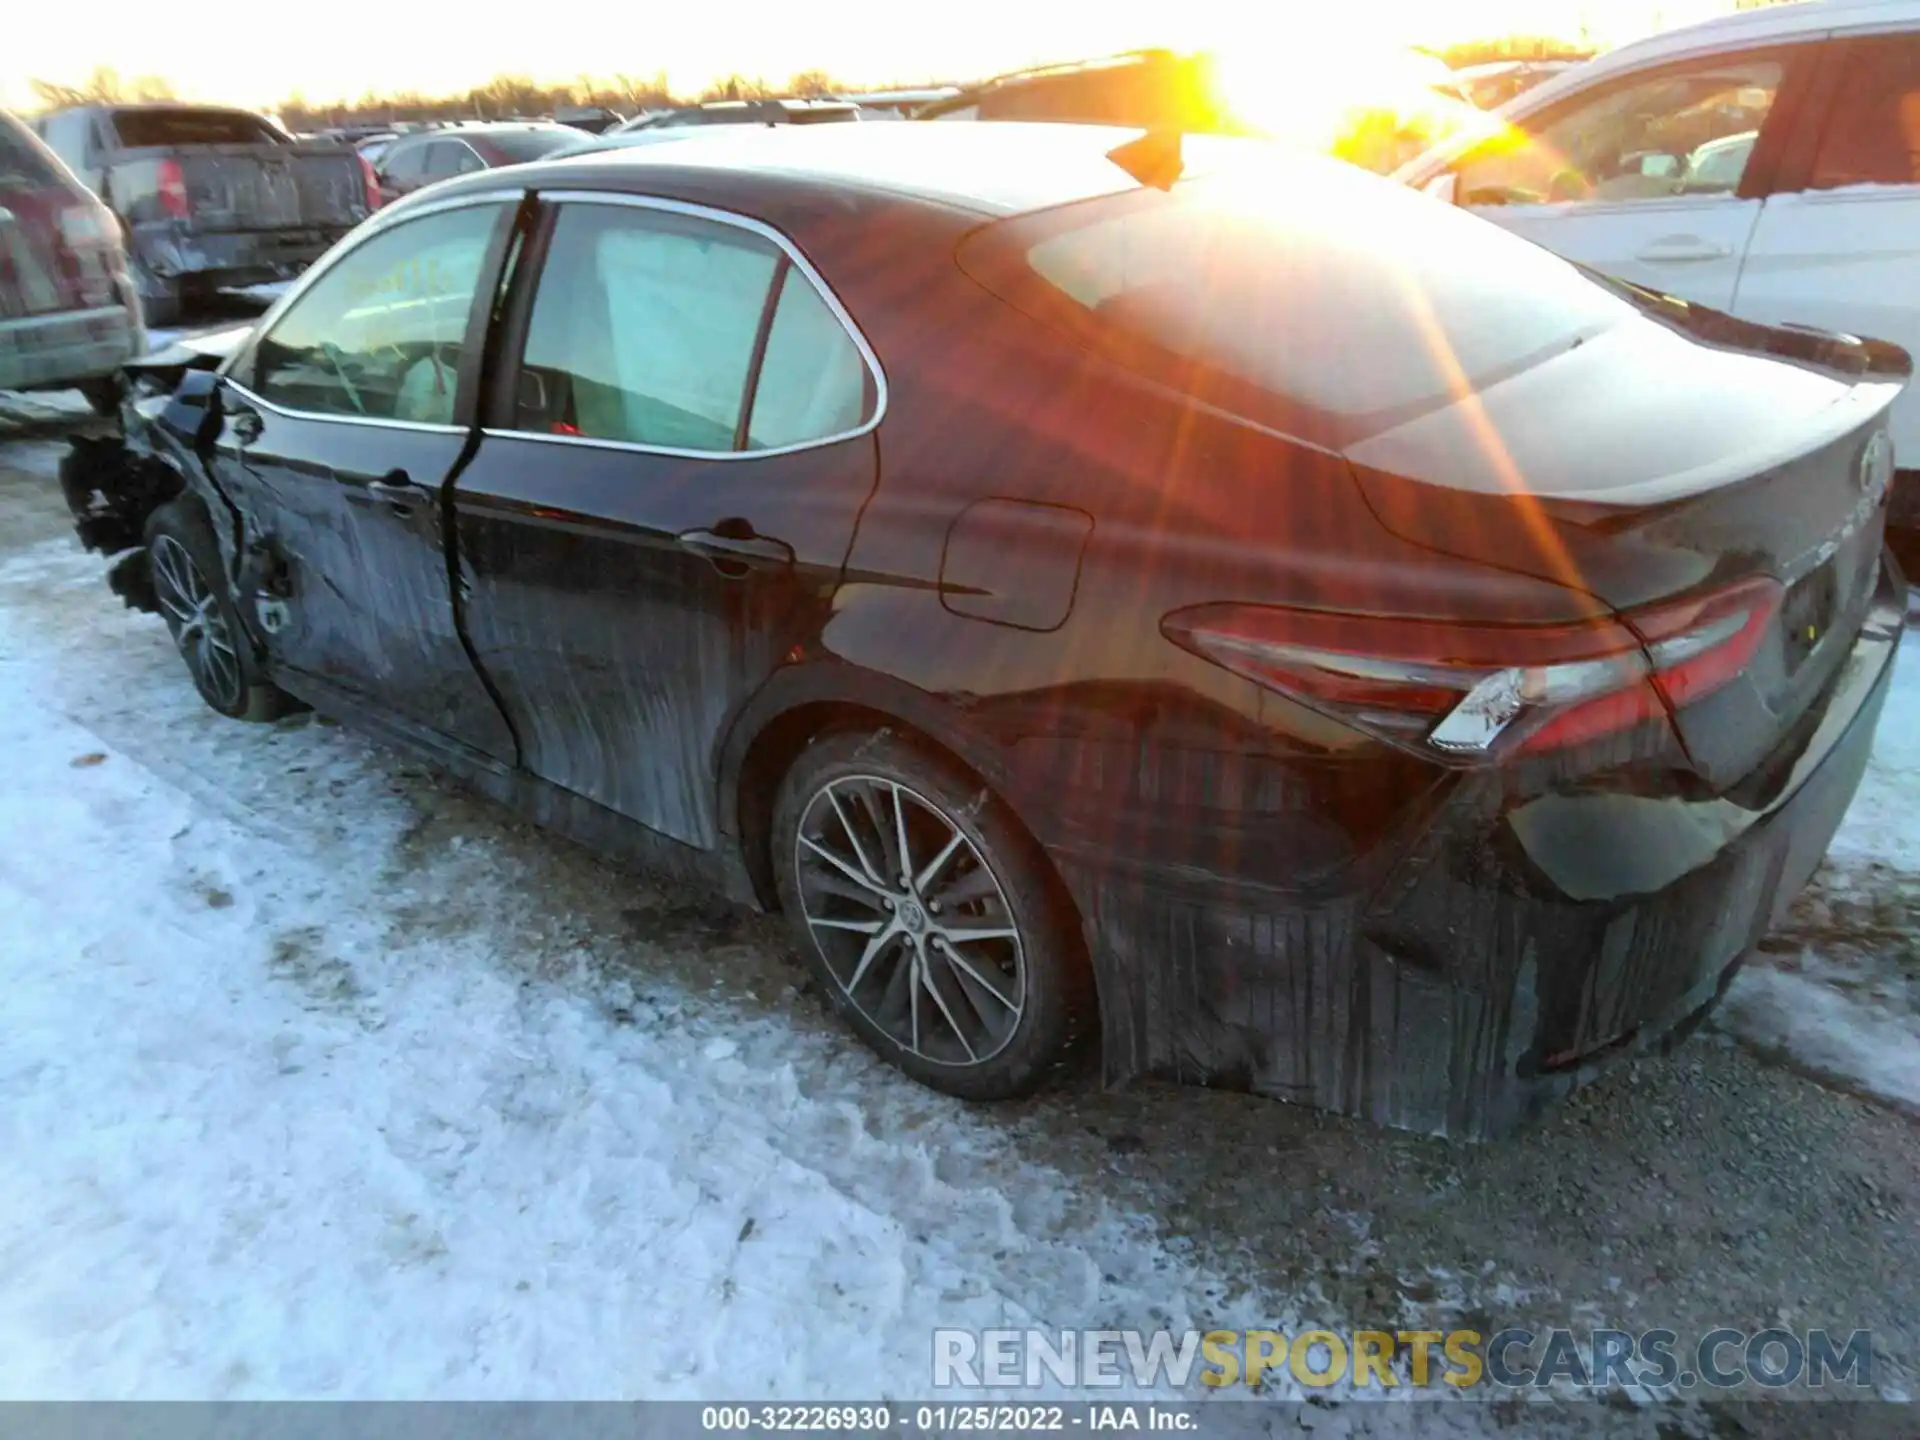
[0,503,1244,1398]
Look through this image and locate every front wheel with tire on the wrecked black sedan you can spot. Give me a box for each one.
[146,497,300,722]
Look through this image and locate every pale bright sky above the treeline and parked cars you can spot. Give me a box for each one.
[0,0,1734,109]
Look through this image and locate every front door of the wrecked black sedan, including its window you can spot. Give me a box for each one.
[207,202,515,760]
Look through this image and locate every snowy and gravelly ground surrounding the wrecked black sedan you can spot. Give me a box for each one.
[0,420,1920,1436]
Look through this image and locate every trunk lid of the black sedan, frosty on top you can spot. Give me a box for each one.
[1348,300,1910,789]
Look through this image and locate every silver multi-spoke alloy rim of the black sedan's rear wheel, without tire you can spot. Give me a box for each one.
[793,774,1027,1066]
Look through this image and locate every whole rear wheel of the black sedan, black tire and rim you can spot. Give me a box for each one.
[772,730,1092,1100]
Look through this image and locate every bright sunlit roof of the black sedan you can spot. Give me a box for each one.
[495,121,1260,215]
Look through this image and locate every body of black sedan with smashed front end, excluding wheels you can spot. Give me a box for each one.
[69,127,1910,1139]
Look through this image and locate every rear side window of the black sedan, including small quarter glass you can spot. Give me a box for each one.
[515,204,868,453]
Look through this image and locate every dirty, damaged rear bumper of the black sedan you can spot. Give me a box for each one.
[1056,564,1905,1139]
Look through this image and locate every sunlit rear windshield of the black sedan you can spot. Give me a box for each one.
[962,161,1634,432]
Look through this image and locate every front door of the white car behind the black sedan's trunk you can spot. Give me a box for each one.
[1453,46,1816,309]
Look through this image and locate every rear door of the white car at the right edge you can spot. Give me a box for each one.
[1734,31,1920,468]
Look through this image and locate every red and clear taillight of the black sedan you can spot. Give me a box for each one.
[1164,580,1780,764]
